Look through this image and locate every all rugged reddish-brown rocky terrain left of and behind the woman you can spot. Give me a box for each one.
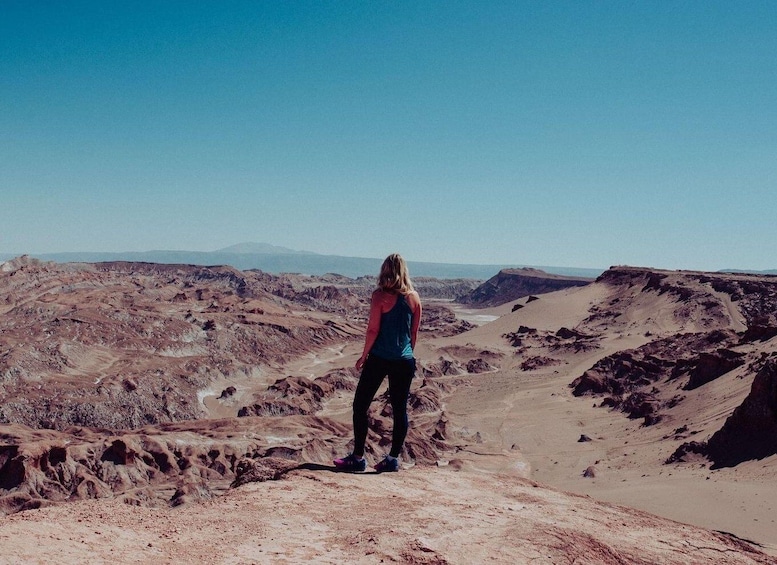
[0,258,475,511]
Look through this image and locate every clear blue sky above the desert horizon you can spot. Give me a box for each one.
[0,0,777,270]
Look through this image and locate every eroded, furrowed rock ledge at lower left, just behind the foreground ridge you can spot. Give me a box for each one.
[0,416,362,513]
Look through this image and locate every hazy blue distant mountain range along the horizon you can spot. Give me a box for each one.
[0,243,604,280]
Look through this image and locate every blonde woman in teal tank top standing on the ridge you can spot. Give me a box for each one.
[334,253,421,473]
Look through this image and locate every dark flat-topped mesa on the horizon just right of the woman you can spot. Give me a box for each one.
[458,268,593,308]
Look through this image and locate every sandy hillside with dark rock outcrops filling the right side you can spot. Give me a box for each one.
[438,267,777,548]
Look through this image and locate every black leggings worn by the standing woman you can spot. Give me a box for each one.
[353,355,415,457]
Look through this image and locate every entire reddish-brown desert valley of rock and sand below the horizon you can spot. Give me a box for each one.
[0,257,777,564]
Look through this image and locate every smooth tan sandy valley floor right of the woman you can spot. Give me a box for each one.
[440,360,777,556]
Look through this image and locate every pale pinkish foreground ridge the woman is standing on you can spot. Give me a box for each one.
[0,466,770,564]
